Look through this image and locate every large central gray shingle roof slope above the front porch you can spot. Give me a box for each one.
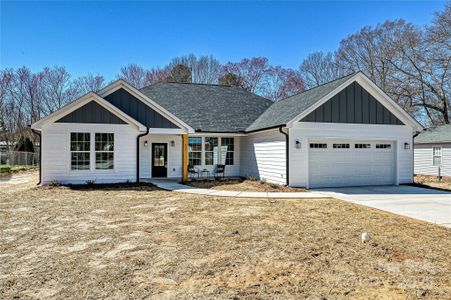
[140,82,273,132]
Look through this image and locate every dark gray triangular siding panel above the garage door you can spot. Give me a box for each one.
[301,82,403,125]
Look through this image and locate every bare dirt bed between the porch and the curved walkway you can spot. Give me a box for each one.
[186,179,307,192]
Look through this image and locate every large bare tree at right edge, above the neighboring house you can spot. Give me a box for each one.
[387,11,451,124]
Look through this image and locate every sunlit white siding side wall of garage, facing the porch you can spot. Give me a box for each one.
[241,129,286,184]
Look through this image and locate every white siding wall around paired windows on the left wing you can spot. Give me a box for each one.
[42,123,138,184]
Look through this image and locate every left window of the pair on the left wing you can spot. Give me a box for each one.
[70,132,91,170]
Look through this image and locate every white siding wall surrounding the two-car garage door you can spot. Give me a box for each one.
[289,122,413,187]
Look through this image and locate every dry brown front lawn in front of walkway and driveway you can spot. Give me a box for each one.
[0,173,451,299]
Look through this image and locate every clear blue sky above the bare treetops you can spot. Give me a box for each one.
[0,1,444,79]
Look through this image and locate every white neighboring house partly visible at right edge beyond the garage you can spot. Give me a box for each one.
[414,125,451,176]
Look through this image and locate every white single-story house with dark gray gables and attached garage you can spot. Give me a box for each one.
[32,72,423,188]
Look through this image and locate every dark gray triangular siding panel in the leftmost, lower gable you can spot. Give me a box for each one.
[56,101,127,124]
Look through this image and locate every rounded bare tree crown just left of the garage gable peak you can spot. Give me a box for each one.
[299,52,342,88]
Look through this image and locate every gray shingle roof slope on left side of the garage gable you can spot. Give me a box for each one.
[246,73,355,131]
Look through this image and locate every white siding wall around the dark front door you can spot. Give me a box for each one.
[139,134,182,178]
